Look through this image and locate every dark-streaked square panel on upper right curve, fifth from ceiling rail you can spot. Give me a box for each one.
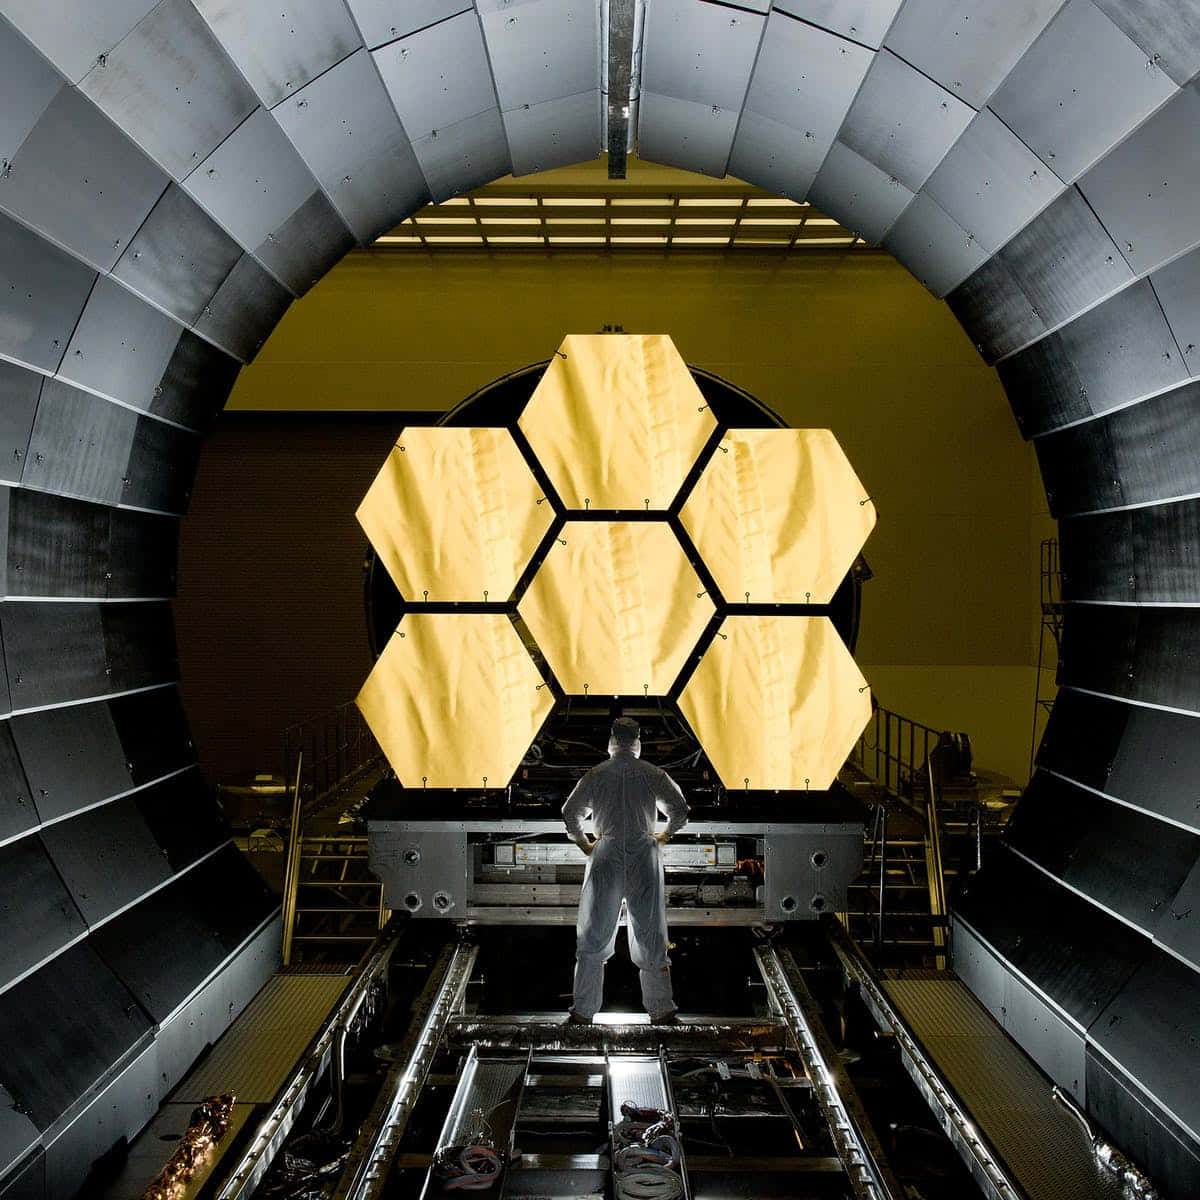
[1000,187,1133,338]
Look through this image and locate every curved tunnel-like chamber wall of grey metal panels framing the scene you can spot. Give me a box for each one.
[0,0,1200,1198]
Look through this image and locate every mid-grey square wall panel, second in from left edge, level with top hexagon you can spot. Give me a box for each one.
[22,379,138,504]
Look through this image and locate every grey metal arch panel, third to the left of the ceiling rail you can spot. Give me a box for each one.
[272,50,428,242]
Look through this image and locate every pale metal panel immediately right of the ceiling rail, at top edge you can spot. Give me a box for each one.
[642,0,763,112]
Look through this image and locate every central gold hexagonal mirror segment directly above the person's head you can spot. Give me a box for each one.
[517,521,715,696]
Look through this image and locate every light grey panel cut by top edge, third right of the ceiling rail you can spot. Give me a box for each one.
[884,0,1063,108]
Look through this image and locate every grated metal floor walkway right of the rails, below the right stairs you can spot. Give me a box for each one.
[881,974,1124,1200]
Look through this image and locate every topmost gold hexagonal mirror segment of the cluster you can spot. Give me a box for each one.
[517,334,716,510]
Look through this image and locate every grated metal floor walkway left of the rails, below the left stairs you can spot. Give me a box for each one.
[170,974,349,1104]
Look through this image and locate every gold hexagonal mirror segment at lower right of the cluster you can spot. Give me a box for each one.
[679,616,871,791]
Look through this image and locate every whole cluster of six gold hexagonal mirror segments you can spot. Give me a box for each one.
[359,335,875,791]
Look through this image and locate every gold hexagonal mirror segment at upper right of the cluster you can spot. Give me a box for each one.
[679,430,875,604]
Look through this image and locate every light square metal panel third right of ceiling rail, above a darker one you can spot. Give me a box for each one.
[838,49,976,192]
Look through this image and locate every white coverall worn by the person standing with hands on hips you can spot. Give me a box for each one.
[563,742,688,1020]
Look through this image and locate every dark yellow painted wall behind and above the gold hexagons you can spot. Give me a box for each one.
[220,251,1042,782]
